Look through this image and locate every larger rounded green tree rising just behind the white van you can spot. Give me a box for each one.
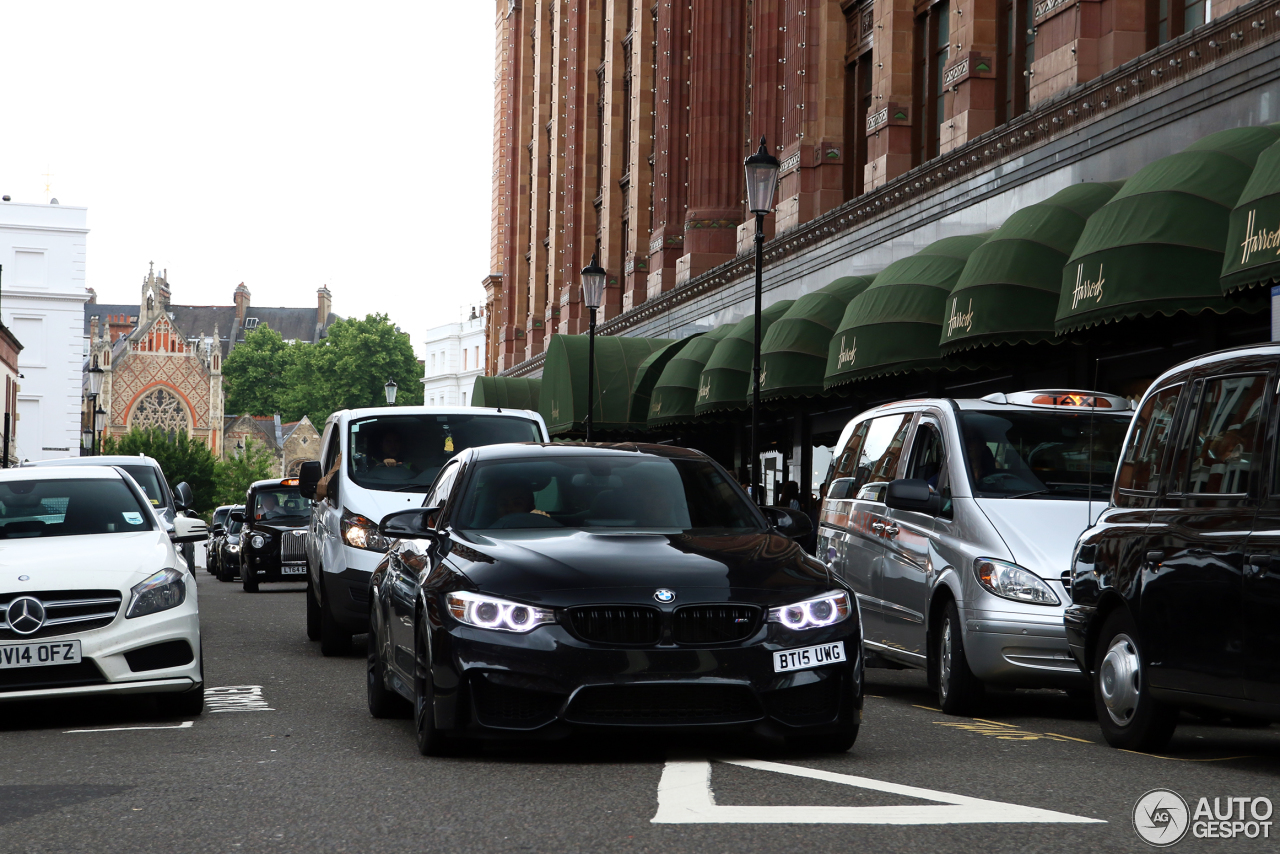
[280,314,422,425]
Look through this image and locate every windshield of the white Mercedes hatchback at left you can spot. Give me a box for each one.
[0,479,155,539]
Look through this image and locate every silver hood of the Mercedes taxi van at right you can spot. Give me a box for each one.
[974,498,1106,579]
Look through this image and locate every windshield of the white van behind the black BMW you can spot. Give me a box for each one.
[347,414,543,492]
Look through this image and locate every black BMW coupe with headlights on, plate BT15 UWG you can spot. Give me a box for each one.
[369,444,863,755]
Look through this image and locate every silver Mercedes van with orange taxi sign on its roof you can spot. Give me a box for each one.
[818,389,1133,714]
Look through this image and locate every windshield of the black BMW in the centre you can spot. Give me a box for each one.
[454,455,764,534]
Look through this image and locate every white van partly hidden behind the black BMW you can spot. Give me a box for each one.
[298,406,550,656]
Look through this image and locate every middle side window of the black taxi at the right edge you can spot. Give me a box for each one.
[1169,374,1267,495]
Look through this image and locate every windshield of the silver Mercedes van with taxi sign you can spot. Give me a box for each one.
[960,411,1130,499]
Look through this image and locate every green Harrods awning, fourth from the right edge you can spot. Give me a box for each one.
[823,232,992,388]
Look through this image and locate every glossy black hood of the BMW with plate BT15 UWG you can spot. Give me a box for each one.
[448,530,832,606]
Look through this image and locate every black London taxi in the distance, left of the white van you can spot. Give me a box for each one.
[239,478,310,593]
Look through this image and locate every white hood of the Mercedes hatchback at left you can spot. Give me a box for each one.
[0,530,178,593]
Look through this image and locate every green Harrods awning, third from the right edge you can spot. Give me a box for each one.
[941,181,1124,356]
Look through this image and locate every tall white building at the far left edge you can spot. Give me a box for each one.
[0,201,88,460]
